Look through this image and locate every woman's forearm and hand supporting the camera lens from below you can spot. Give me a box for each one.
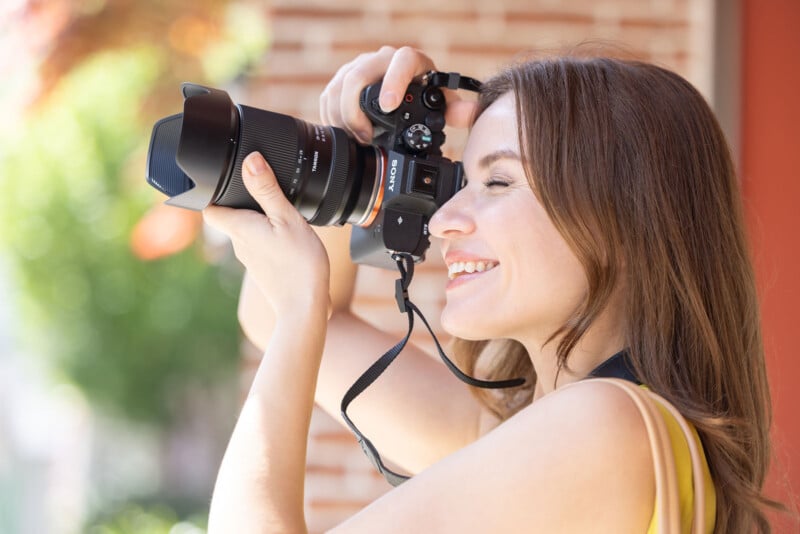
[204,154,330,533]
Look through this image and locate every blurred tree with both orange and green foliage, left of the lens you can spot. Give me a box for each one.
[0,0,267,428]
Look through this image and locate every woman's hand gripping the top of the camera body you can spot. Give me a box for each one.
[319,46,476,143]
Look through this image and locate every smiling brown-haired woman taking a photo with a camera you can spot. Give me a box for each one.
[205,47,770,532]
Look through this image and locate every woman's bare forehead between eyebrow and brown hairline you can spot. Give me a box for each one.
[463,93,519,166]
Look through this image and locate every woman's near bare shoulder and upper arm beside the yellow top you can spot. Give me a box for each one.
[332,381,655,532]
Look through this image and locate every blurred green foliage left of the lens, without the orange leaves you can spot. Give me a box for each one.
[0,10,266,423]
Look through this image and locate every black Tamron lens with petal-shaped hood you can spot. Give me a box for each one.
[147,84,383,226]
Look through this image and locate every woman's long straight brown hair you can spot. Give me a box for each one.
[455,57,771,532]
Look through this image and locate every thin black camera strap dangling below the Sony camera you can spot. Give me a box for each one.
[341,253,525,486]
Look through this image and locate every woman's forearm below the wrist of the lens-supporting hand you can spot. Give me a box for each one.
[209,302,327,533]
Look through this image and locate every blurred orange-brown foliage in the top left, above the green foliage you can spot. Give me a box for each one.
[27,0,267,109]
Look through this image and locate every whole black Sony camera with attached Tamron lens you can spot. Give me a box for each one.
[146,72,480,269]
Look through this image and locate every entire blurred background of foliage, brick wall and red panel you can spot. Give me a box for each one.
[0,0,800,534]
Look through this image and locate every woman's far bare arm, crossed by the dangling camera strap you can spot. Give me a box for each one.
[239,266,496,473]
